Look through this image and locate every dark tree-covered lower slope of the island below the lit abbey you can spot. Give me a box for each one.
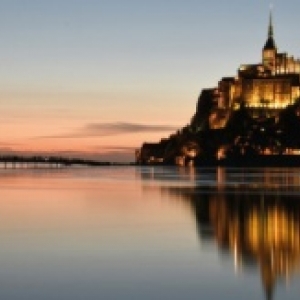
[139,97,300,165]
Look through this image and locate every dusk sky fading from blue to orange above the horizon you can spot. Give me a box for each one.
[0,0,300,161]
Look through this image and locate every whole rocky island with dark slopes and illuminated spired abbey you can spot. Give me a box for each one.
[136,13,300,166]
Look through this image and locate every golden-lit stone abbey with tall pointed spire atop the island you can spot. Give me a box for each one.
[207,10,300,128]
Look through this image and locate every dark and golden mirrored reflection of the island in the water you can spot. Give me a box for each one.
[142,168,300,299]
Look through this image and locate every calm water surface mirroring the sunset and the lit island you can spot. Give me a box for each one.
[0,167,300,300]
